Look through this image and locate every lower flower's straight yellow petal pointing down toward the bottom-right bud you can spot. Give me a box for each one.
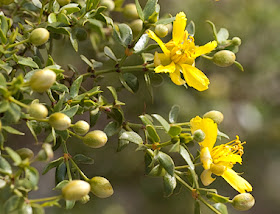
[222,169,253,193]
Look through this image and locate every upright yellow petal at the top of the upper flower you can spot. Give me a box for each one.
[172,12,187,44]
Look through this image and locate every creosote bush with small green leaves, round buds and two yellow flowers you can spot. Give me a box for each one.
[0,0,254,214]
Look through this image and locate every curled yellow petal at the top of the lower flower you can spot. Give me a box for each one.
[190,116,218,151]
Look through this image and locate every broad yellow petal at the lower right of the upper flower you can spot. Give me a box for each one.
[181,64,210,91]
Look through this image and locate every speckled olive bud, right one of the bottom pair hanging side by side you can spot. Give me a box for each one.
[89,177,114,198]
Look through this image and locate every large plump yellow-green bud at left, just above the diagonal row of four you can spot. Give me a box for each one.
[29,69,56,93]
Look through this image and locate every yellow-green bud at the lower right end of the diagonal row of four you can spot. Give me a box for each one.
[83,130,108,148]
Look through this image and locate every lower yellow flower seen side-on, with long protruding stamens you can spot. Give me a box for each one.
[190,116,252,193]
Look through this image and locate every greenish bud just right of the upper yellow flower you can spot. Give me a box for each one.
[212,50,236,67]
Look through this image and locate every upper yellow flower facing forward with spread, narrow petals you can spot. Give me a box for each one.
[147,12,217,91]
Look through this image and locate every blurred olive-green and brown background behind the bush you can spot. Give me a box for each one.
[19,0,280,214]
